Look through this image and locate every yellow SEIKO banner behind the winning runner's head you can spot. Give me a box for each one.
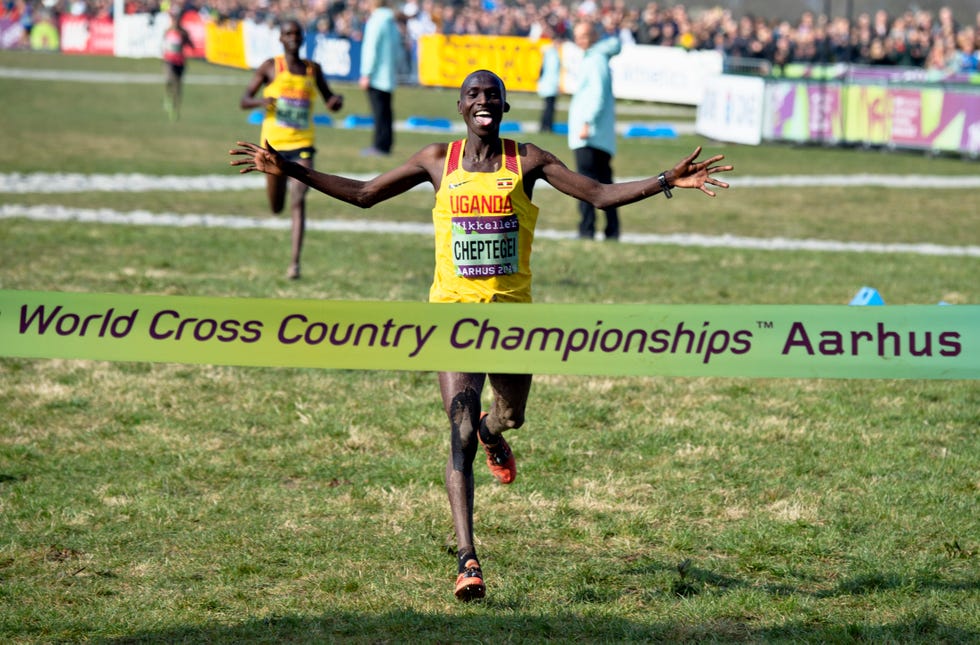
[418,34,549,92]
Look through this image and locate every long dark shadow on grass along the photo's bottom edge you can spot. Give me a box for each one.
[93,611,980,645]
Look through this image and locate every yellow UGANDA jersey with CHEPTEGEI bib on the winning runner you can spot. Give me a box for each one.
[429,139,538,302]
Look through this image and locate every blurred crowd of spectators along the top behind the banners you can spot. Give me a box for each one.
[0,0,980,72]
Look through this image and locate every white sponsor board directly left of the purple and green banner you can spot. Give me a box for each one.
[694,75,766,145]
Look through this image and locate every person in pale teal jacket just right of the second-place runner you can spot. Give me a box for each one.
[360,0,402,155]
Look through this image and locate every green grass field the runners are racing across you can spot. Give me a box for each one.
[0,52,980,643]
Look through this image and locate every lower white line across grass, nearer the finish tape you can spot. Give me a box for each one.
[0,204,980,257]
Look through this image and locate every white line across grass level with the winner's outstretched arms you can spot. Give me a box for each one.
[0,170,980,194]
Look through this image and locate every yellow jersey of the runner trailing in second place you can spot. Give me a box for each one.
[261,56,317,150]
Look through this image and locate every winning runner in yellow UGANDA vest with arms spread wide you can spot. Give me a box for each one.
[230,70,732,601]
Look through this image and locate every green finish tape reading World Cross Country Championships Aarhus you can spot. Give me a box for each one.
[0,291,980,379]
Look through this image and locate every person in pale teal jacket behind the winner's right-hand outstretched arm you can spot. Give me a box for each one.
[568,20,621,241]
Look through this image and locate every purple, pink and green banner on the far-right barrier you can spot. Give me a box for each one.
[763,82,980,154]
